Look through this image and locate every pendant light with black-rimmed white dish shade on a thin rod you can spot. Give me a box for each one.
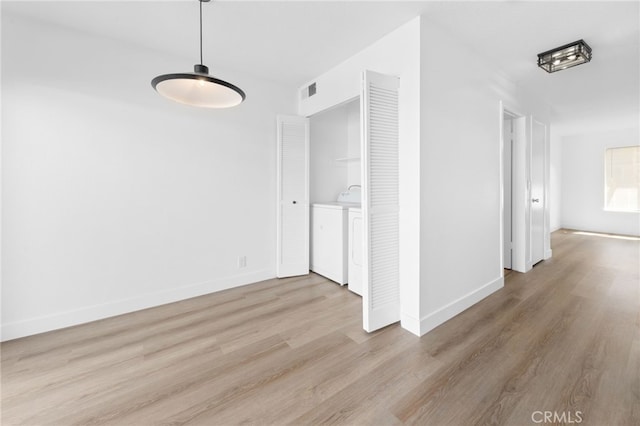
[151,0,246,108]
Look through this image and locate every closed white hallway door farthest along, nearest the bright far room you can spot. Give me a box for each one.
[531,120,546,265]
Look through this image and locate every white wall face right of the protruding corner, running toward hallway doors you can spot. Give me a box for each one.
[420,17,549,334]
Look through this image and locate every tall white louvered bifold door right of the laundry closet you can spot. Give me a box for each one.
[361,71,400,331]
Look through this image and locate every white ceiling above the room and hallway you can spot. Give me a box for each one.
[2,0,640,131]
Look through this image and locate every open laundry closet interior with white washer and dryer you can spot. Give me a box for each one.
[309,97,363,295]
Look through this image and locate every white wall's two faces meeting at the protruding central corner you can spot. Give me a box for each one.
[299,17,551,335]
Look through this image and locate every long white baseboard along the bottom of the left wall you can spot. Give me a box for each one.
[0,269,275,342]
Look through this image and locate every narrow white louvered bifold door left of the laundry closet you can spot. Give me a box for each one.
[276,115,309,278]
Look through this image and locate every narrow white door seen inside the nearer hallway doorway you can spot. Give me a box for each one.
[502,114,513,269]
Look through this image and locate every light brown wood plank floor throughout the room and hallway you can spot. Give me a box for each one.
[1,231,640,425]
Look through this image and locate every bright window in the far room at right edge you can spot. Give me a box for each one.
[604,146,640,212]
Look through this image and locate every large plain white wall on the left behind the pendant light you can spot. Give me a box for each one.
[2,12,295,340]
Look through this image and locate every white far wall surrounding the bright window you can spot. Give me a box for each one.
[561,126,640,236]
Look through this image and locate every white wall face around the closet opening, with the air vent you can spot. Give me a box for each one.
[298,17,421,334]
